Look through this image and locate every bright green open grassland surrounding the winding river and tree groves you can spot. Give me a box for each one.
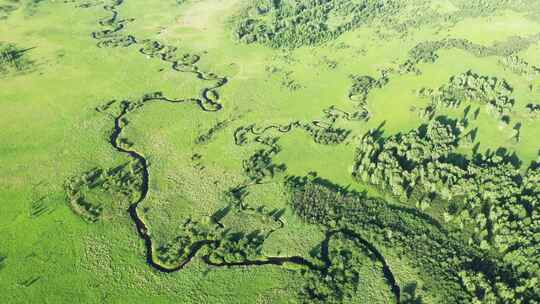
[0,0,540,304]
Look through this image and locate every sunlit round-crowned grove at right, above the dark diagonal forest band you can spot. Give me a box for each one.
[354,120,540,303]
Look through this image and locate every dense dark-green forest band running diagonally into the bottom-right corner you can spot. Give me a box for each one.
[288,175,540,303]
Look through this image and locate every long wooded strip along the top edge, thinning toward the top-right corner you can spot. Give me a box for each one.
[233,0,540,48]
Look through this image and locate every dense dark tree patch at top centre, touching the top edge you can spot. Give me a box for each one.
[234,0,400,48]
